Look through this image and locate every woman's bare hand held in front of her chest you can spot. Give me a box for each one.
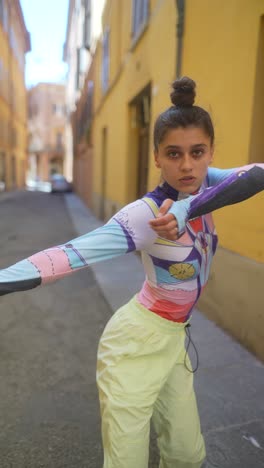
[149,198,179,241]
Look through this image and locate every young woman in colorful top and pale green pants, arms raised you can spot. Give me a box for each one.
[0,77,264,468]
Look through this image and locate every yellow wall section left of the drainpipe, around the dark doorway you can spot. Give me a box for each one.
[94,0,177,209]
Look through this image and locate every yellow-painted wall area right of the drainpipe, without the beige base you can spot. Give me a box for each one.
[182,0,264,262]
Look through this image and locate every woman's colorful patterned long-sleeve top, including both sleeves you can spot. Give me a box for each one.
[0,164,264,322]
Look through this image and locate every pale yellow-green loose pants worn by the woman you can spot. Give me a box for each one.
[97,299,205,468]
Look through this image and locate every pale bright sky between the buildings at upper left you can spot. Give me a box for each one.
[20,0,69,87]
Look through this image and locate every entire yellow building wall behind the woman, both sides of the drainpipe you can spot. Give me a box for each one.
[93,0,264,359]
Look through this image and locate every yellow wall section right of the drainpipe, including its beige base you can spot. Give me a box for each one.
[179,0,264,360]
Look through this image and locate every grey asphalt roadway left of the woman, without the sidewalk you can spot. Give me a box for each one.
[0,192,111,468]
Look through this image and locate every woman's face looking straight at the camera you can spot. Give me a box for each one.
[155,126,213,193]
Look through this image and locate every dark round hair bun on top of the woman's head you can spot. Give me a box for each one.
[170,76,196,107]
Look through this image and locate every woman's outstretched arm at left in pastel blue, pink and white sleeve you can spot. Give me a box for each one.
[0,200,156,295]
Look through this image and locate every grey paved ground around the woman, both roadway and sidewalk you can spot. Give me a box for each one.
[0,192,264,468]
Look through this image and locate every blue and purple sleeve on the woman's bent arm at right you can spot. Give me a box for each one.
[169,164,264,235]
